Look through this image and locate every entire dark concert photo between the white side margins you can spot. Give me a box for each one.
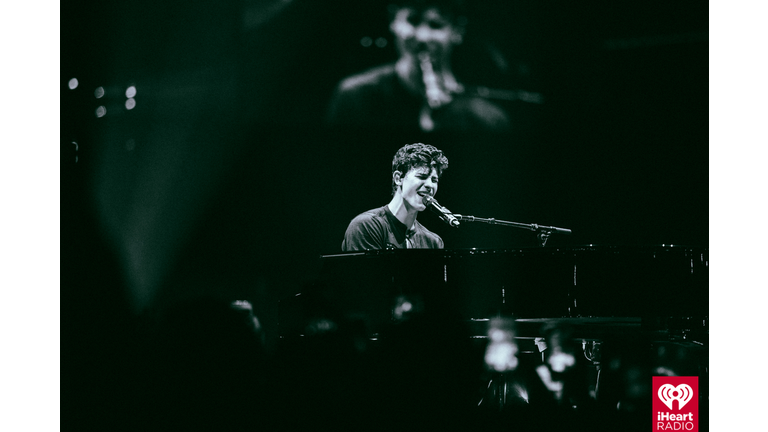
[9,0,740,431]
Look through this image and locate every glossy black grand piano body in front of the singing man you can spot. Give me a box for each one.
[280,245,709,340]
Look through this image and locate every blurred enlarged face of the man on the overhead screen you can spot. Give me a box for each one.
[390,8,461,61]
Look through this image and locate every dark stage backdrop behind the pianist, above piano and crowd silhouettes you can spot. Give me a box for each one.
[61,0,709,344]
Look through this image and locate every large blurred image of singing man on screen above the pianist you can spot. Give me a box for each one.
[326,0,510,133]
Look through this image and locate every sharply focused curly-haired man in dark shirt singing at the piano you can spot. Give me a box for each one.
[341,143,448,252]
